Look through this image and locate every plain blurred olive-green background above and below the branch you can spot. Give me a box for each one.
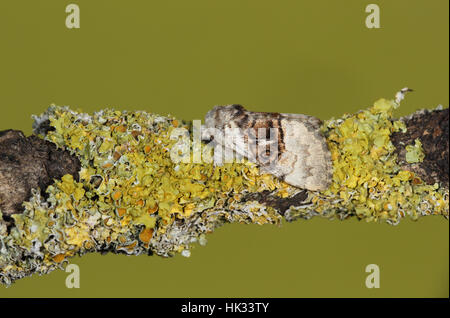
[0,0,449,297]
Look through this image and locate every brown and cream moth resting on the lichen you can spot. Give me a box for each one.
[202,104,333,191]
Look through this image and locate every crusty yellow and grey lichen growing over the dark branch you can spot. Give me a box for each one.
[0,99,449,284]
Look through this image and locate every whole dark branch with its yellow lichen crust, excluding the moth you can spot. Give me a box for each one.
[0,93,449,284]
